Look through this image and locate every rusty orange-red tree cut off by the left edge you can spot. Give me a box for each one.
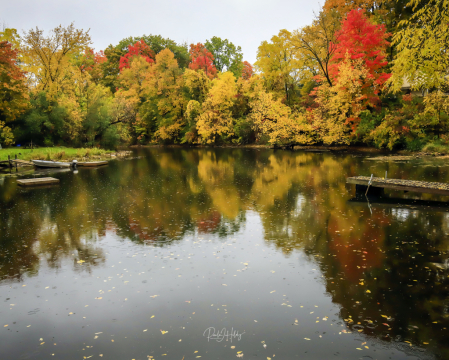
[0,41,28,145]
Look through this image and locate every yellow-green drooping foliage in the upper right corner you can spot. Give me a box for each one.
[390,0,449,91]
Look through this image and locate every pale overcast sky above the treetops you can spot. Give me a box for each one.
[0,0,324,63]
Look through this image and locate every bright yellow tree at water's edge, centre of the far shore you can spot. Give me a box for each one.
[196,71,237,144]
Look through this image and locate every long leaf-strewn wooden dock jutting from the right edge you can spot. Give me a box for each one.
[346,176,449,196]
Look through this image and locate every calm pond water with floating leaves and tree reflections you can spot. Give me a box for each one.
[0,148,449,360]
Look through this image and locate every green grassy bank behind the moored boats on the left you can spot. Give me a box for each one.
[0,147,115,161]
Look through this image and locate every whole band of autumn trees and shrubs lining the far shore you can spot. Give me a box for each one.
[0,0,449,156]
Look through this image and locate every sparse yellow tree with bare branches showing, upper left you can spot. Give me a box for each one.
[22,23,91,96]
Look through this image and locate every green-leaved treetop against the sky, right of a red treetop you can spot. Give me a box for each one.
[205,36,243,78]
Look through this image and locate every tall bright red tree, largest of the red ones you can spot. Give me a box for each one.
[329,9,391,105]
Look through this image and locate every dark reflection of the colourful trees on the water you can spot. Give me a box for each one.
[0,148,449,358]
